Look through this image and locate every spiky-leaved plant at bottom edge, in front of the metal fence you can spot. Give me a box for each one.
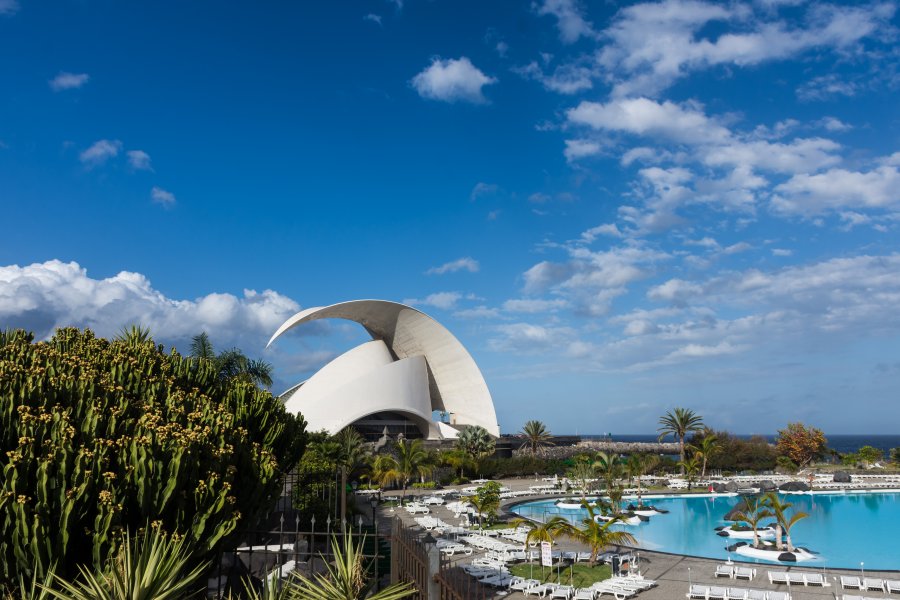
[288,533,416,600]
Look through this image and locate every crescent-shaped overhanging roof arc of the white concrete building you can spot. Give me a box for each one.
[267,300,500,436]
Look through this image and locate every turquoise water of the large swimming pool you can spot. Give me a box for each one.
[513,492,900,570]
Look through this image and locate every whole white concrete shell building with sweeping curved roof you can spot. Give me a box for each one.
[268,300,500,439]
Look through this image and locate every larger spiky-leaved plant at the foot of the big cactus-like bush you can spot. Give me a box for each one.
[39,527,208,600]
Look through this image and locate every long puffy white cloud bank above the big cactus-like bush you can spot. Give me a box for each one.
[0,260,300,346]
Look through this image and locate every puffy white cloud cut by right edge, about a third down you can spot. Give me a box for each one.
[772,166,900,216]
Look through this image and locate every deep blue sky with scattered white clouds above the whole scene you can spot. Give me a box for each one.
[0,0,900,433]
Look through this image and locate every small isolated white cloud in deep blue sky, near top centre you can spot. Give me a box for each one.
[410,56,497,104]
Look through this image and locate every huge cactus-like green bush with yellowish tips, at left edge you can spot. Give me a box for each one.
[0,329,305,582]
